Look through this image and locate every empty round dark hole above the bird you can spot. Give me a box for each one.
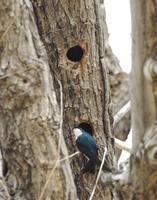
[66,45,84,62]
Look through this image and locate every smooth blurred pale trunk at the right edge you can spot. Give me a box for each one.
[106,0,157,200]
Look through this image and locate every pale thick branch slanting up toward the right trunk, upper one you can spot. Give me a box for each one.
[113,101,131,126]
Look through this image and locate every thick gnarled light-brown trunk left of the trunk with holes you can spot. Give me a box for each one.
[0,0,77,200]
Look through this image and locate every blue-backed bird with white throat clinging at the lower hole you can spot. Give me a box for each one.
[73,127,110,174]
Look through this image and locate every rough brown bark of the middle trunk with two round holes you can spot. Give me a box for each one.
[32,0,114,199]
